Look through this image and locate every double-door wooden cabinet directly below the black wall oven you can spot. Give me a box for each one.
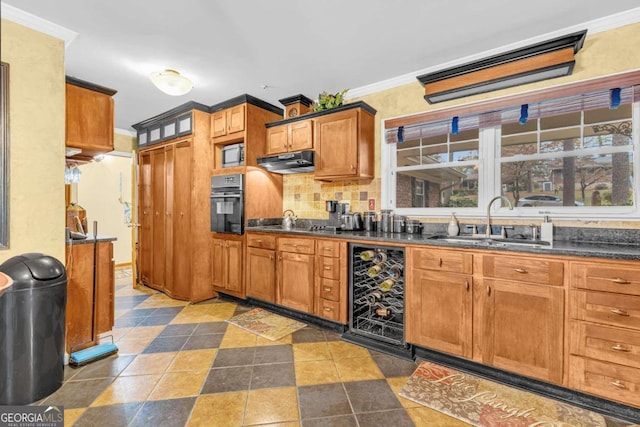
[211,237,245,298]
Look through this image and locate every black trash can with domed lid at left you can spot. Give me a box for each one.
[0,253,67,405]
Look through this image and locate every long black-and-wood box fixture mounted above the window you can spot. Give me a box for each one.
[417,30,587,104]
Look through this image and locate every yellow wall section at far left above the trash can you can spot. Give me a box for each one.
[0,19,65,262]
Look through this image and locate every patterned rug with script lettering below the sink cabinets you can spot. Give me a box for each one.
[399,361,632,427]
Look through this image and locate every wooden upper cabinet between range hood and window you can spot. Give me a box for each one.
[314,108,375,181]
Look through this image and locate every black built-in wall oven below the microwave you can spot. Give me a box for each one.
[211,174,244,234]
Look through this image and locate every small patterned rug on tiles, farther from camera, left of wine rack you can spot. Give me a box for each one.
[227,308,307,341]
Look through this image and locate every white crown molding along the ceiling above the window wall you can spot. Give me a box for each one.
[346,7,640,99]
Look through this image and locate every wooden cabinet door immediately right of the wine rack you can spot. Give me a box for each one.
[406,269,473,358]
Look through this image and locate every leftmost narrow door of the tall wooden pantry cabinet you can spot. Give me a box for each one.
[138,152,154,285]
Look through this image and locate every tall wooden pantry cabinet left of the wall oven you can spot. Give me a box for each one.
[134,106,214,301]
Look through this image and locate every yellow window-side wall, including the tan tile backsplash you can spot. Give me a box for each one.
[283,23,640,225]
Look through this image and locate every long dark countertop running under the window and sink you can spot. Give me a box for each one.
[245,227,640,261]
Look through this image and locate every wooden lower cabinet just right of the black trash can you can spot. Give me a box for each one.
[65,241,115,353]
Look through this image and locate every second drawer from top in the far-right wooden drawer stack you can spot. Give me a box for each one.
[569,290,640,331]
